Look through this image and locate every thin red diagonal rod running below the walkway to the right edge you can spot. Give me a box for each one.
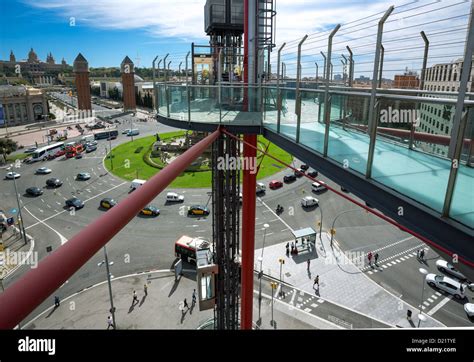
[222,129,474,268]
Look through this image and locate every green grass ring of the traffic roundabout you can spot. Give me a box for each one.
[105,131,292,188]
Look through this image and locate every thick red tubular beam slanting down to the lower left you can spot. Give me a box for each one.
[0,129,221,329]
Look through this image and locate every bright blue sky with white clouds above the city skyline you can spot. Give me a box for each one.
[0,0,469,77]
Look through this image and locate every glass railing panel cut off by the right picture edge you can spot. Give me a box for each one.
[450,108,474,228]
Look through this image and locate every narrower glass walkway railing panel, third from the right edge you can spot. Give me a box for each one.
[328,95,370,175]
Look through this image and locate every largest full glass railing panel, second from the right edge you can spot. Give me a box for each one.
[372,99,454,212]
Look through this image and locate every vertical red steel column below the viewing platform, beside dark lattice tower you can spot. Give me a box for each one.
[241,135,257,329]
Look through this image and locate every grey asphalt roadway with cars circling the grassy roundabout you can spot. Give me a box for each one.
[0,116,473,326]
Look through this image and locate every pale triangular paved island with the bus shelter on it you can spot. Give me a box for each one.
[254,233,444,328]
